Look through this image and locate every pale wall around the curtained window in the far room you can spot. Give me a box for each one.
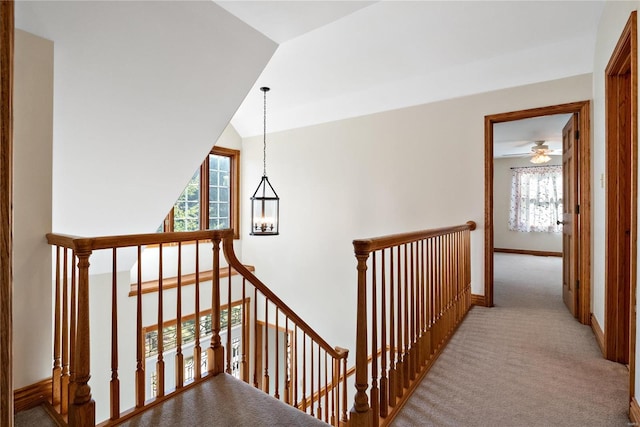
[493,156,562,252]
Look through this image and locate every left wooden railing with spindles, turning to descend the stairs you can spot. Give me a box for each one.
[47,230,348,426]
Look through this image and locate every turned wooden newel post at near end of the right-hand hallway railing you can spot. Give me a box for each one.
[349,242,373,427]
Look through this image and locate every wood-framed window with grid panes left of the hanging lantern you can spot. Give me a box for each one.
[158,147,240,239]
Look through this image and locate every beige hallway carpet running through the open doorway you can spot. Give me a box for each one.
[392,254,629,427]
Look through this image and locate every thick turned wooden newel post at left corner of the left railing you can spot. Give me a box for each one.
[69,239,96,427]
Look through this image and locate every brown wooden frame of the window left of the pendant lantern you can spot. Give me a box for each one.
[162,146,240,240]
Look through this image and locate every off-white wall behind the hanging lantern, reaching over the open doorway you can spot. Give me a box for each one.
[242,75,592,354]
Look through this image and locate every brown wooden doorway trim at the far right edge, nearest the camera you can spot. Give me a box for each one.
[604,11,638,408]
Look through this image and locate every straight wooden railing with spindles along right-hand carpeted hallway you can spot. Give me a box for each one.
[350,221,476,427]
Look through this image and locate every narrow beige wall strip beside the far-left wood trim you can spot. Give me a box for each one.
[13,30,53,388]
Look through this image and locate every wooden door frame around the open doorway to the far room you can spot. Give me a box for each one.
[484,101,591,324]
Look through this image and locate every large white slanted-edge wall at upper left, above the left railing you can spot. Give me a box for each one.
[16,1,277,254]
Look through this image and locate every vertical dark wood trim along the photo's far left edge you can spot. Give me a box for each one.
[0,0,14,427]
